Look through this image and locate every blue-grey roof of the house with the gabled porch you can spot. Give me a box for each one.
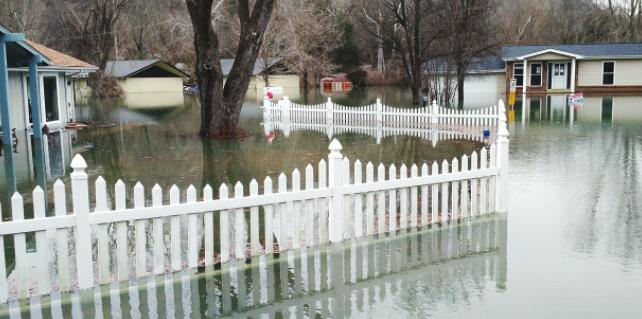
[502,43,642,61]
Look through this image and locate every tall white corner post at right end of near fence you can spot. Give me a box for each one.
[495,100,509,213]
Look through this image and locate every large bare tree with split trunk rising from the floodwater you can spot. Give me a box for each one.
[185,0,275,138]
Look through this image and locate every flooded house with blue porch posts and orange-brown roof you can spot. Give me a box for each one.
[0,25,97,144]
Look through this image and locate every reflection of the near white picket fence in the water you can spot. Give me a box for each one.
[0,214,507,318]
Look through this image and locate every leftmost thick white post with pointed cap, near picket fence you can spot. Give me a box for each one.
[71,154,94,290]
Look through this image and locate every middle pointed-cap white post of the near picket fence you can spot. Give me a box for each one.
[328,139,343,243]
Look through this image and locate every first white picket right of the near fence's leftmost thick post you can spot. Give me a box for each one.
[95,176,110,284]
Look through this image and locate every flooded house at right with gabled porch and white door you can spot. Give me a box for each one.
[502,43,642,94]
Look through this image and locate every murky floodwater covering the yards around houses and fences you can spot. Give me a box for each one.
[0,88,642,318]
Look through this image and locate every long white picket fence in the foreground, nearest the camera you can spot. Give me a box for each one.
[0,101,509,302]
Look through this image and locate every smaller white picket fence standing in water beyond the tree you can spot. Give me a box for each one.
[263,97,506,128]
